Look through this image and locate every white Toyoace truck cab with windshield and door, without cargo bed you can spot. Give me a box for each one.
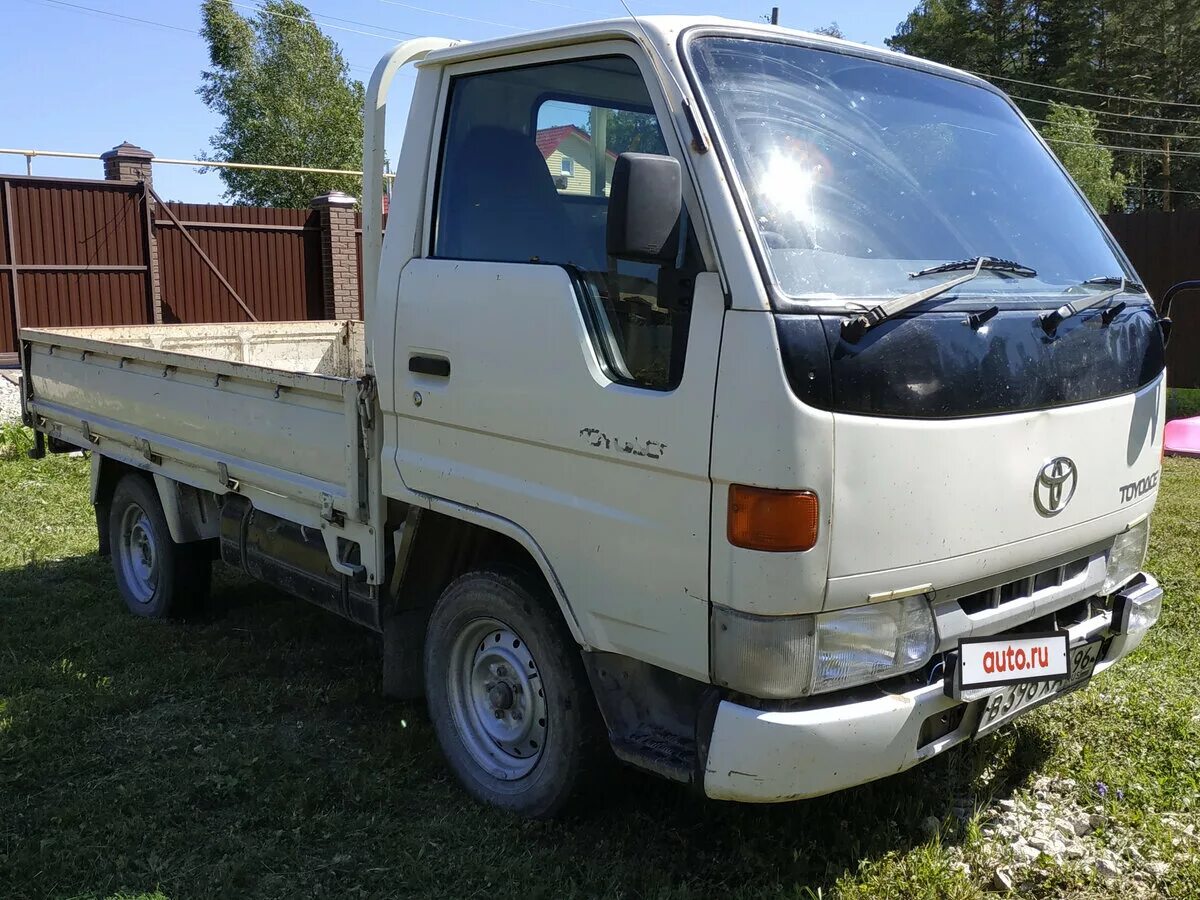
[373,19,1164,800]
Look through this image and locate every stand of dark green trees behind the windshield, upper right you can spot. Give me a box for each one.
[888,0,1200,210]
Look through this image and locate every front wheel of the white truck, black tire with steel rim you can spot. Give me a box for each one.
[425,570,604,818]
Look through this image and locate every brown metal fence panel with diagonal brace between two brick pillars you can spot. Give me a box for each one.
[162,203,325,323]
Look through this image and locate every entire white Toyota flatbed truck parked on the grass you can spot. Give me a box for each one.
[22,18,1169,816]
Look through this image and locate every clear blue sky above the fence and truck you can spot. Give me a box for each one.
[0,0,916,203]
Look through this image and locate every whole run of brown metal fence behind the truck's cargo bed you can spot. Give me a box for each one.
[0,175,343,365]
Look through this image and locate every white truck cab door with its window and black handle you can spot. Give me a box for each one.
[395,42,725,680]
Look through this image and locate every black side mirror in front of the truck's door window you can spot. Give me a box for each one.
[607,154,683,265]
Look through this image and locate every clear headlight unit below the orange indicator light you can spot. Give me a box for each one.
[712,596,937,700]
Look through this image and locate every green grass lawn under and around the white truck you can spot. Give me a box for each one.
[0,433,1200,900]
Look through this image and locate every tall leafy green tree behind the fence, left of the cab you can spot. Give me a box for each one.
[197,0,362,206]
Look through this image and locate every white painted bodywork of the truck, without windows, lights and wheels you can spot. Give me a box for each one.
[22,18,1165,816]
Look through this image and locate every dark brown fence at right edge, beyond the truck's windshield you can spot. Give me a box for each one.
[1104,217,1200,388]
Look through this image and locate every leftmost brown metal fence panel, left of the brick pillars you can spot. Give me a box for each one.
[0,175,152,362]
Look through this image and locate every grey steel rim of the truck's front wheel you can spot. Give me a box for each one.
[446,618,548,781]
